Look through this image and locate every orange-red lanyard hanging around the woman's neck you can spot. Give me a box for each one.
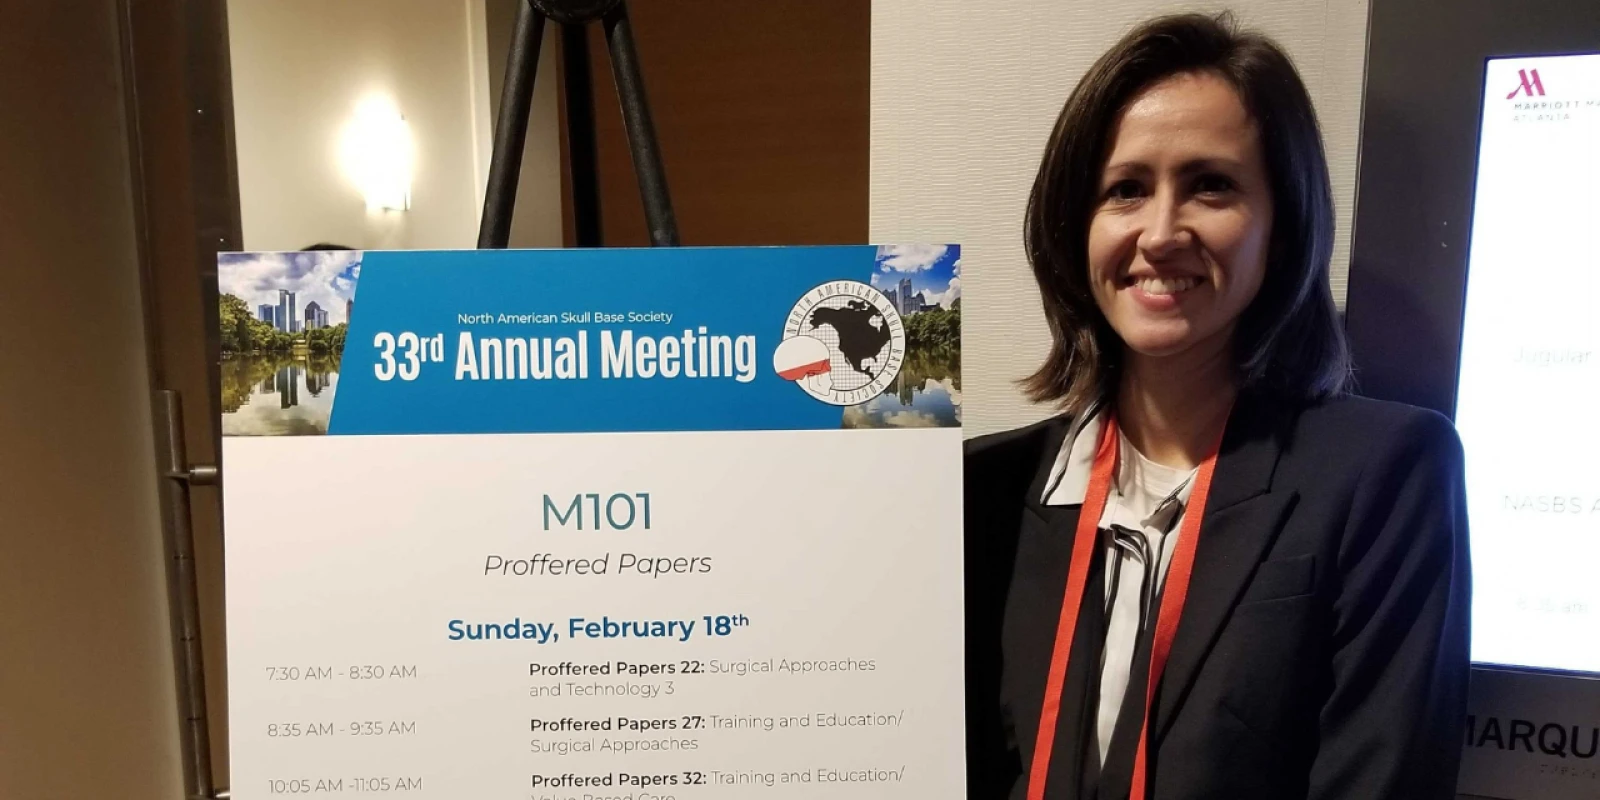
[1027,413,1216,800]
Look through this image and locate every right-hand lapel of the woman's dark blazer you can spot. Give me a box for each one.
[1154,397,1296,741]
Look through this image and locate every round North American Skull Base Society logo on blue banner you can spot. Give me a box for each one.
[773,280,906,405]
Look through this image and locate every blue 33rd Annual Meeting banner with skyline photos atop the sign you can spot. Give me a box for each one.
[218,245,962,435]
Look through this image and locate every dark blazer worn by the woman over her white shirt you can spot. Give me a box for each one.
[965,395,1470,800]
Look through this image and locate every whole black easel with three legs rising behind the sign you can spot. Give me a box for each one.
[478,0,678,250]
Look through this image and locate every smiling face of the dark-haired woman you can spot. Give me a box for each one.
[1088,74,1272,366]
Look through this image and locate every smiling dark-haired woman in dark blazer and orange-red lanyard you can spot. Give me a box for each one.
[966,16,1470,800]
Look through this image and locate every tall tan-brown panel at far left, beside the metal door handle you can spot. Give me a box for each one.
[0,6,182,800]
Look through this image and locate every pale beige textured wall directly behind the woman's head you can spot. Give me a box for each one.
[870,0,1368,434]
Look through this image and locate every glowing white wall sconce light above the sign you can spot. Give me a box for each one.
[341,96,414,211]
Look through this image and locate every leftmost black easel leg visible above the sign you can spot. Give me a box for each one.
[478,0,544,250]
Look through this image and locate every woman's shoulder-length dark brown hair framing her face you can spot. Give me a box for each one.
[1024,14,1350,414]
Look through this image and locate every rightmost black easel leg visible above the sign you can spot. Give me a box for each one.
[605,2,678,246]
